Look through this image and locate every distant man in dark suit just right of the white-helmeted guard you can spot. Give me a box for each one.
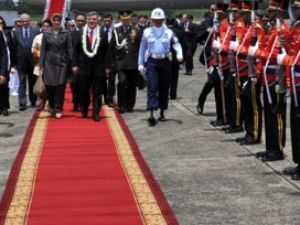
[181,14,197,75]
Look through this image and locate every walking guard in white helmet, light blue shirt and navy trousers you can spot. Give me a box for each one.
[138,8,183,126]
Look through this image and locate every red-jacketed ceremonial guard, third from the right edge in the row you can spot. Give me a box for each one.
[236,1,268,145]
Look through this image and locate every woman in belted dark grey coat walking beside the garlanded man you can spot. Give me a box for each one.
[39,14,72,119]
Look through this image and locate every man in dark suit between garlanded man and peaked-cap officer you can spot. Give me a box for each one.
[101,14,117,107]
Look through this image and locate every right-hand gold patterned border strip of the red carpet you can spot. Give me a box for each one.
[103,106,167,225]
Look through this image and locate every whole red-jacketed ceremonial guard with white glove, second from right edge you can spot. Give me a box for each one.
[248,0,290,161]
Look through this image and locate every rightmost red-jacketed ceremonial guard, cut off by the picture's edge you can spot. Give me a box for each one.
[277,0,300,180]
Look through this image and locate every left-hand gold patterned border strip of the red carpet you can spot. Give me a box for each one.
[4,111,49,225]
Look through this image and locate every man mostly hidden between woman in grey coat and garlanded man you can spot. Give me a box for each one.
[70,13,86,112]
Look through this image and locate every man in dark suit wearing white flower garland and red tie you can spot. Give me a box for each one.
[72,12,108,122]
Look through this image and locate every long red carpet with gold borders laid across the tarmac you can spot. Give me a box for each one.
[0,86,178,225]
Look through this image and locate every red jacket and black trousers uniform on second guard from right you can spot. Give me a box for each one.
[251,20,290,161]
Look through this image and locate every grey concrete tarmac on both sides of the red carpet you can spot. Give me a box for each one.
[0,52,300,225]
